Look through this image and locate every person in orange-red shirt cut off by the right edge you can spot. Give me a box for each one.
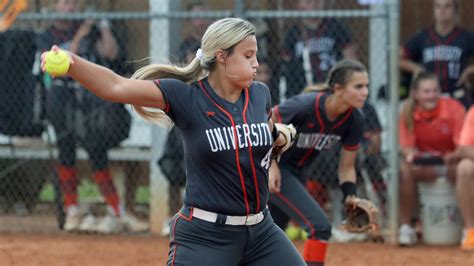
[446,106,474,251]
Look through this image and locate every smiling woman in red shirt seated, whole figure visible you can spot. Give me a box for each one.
[399,72,465,245]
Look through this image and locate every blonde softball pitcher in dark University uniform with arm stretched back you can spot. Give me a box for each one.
[42,18,305,266]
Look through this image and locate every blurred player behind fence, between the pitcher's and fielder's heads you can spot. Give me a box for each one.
[281,0,357,98]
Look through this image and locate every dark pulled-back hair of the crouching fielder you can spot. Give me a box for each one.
[303,59,367,92]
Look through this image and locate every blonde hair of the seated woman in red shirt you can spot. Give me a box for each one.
[401,72,439,132]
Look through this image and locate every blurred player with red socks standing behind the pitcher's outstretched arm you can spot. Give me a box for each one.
[38,0,148,233]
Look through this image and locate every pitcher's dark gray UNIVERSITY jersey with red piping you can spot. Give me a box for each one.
[155,78,273,215]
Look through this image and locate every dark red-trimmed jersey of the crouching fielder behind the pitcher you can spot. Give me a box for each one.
[273,92,364,170]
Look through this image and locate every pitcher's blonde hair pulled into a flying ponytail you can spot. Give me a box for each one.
[131,18,255,125]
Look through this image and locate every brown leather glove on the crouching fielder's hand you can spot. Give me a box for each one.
[341,196,381,241]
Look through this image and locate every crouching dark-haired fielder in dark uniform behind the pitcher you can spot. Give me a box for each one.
[269,59,369,265]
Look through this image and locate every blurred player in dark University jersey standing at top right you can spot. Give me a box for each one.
[400,0,474,108]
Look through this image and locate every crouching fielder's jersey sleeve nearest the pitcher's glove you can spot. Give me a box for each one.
[273,93,314,126]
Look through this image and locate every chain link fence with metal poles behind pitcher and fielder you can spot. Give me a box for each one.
[0,0,398,240]
